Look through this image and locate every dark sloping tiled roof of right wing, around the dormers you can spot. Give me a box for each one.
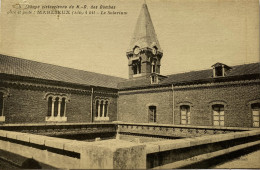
[118,63,260,89]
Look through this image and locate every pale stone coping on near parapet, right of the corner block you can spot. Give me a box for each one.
[145,130,260,154]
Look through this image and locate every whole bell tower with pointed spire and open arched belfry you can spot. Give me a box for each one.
[126,3,163,79]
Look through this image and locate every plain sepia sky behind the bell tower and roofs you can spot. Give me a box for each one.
[0,0,259,78]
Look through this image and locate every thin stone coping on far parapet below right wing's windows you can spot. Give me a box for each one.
[116,121,254,131]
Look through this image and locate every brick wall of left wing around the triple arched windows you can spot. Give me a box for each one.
[3,86,117,123]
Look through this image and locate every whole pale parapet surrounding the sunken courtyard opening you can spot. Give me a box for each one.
[0,122,260,169]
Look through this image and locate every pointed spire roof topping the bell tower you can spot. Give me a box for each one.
[128,0,162,52]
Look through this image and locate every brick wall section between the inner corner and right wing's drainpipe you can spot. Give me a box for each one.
[118,91,172,123]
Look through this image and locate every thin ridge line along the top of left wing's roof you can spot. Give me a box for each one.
[0,53,125,79]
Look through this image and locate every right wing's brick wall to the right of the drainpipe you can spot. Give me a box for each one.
[174,84,260,127]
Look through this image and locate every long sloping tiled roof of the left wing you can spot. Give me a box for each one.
[0,54,125,88]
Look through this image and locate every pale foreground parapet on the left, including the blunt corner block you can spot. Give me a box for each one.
[0,130,146,169]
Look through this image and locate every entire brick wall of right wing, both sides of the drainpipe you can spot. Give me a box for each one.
[118,81,260,127]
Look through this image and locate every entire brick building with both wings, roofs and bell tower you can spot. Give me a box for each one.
[0,4,260,127]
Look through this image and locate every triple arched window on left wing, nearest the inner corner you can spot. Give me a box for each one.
[94,99,109,121]
